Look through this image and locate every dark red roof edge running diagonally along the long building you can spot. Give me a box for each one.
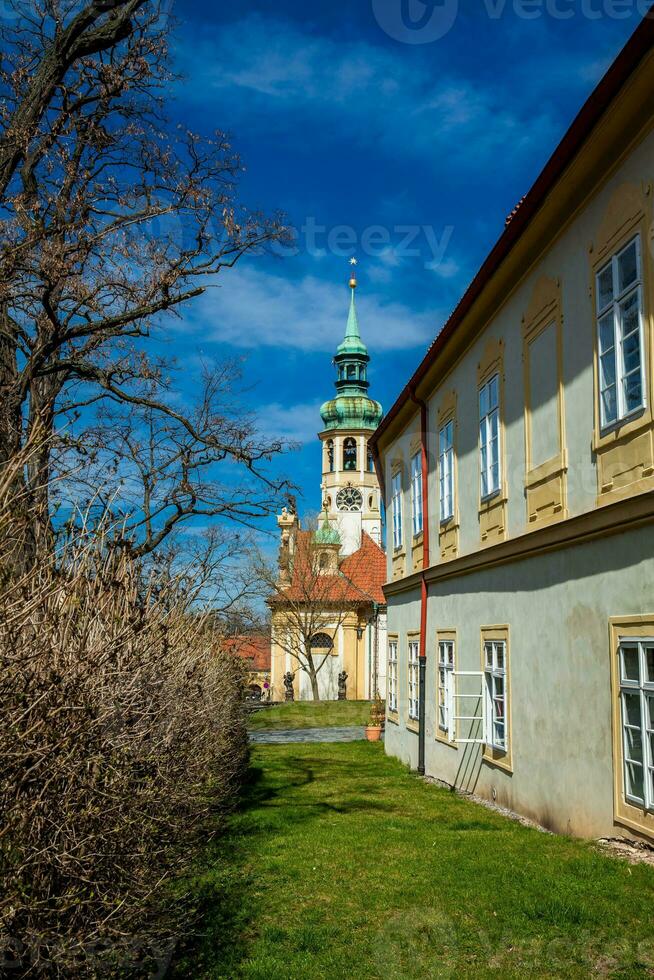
[369,10,654,448]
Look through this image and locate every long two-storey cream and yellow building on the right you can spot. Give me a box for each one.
[372,18,654,840]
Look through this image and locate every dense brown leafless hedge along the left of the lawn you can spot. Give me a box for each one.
[0,478,247,977]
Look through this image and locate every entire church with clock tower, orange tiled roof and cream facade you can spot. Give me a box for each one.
[269,264,386,701]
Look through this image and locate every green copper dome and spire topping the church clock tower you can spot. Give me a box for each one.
[320,276,384,430]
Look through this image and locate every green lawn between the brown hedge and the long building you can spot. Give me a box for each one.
[175,742,654,980]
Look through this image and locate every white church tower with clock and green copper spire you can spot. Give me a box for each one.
[319,259,383,555]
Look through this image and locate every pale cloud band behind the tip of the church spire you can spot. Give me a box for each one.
[182,266,442,353]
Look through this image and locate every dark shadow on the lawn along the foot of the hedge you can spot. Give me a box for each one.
[169,756,394,980]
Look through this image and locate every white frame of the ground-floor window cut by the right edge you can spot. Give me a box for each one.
[618,637,654,811]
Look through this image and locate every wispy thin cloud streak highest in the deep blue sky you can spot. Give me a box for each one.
[173,14,552,170]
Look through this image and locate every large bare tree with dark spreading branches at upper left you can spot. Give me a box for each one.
[0,0,286,553]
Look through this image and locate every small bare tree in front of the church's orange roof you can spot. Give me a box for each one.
[258,524,373,701]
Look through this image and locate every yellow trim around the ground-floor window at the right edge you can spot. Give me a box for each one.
[609,613,654,838]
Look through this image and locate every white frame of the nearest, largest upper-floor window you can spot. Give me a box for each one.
[595,234,647,431]
